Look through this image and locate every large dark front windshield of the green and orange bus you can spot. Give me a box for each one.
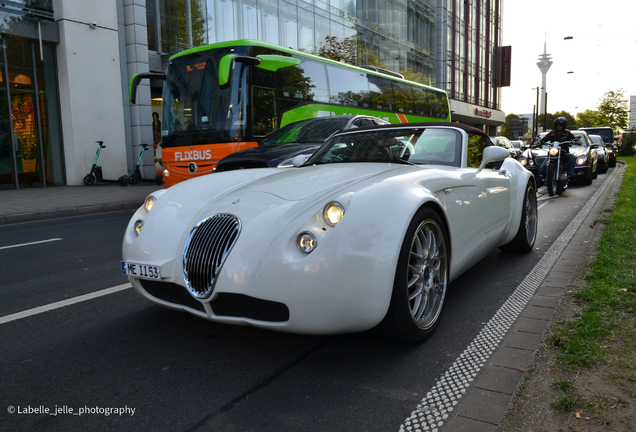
[161,48,247,147]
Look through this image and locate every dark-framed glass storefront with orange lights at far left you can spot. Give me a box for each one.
[0,1,64,189]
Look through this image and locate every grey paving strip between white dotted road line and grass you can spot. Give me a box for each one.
[441,164,625,432]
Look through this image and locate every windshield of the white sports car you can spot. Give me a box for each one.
[305,128,462,167]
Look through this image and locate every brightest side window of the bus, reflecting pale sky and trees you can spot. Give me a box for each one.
[327,65,369,108]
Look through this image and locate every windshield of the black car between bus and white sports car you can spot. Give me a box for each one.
[261,116,349,146]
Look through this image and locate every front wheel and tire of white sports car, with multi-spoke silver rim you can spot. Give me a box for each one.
[377,208,450,342]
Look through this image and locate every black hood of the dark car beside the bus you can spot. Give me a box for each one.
[216,143,322,171]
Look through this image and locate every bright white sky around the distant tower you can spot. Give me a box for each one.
[501,0,636,116]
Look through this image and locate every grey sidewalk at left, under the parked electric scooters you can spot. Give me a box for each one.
[0,184,162,225]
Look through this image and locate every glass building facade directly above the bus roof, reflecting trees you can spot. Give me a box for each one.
[146,0,435,84]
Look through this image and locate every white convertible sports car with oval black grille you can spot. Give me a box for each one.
[122,123,537,340]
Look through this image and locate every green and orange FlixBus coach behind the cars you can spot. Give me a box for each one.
[130,39,450,187]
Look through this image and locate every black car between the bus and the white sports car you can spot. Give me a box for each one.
[214,115,389,172]
